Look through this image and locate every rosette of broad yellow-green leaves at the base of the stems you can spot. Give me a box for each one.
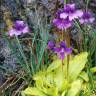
[22,52,89,96]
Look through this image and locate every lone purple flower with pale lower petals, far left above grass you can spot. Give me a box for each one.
[8,20,29,36]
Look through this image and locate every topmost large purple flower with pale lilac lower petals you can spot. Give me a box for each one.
[60,4,83,21]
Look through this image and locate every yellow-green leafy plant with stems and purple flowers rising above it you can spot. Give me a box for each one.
[22,4,95,96]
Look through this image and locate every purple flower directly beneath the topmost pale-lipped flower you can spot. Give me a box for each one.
[53,18,72,30]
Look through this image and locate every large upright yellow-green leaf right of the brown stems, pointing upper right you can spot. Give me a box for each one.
[68,52,88,81]
